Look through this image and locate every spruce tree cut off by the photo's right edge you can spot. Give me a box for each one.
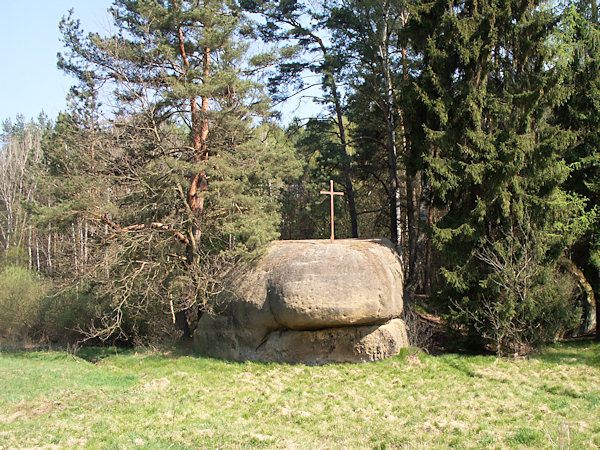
[556,1,600,340]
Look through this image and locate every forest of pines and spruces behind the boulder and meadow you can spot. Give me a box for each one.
[0,0,600,354]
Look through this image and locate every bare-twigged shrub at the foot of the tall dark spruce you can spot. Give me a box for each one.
[450,221,581,354]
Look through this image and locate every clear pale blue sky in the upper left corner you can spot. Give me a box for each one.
[0,0,112,122]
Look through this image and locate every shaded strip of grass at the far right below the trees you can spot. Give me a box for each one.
[532,338,600,368]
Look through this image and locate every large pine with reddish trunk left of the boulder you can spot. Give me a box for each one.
[59,0,295,339]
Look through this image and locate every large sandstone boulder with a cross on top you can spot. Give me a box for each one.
[194,239,408,364]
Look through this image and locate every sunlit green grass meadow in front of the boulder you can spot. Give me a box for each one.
[0,341,600,448]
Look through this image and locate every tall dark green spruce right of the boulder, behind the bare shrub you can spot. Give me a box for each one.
[414,0,572,351]
